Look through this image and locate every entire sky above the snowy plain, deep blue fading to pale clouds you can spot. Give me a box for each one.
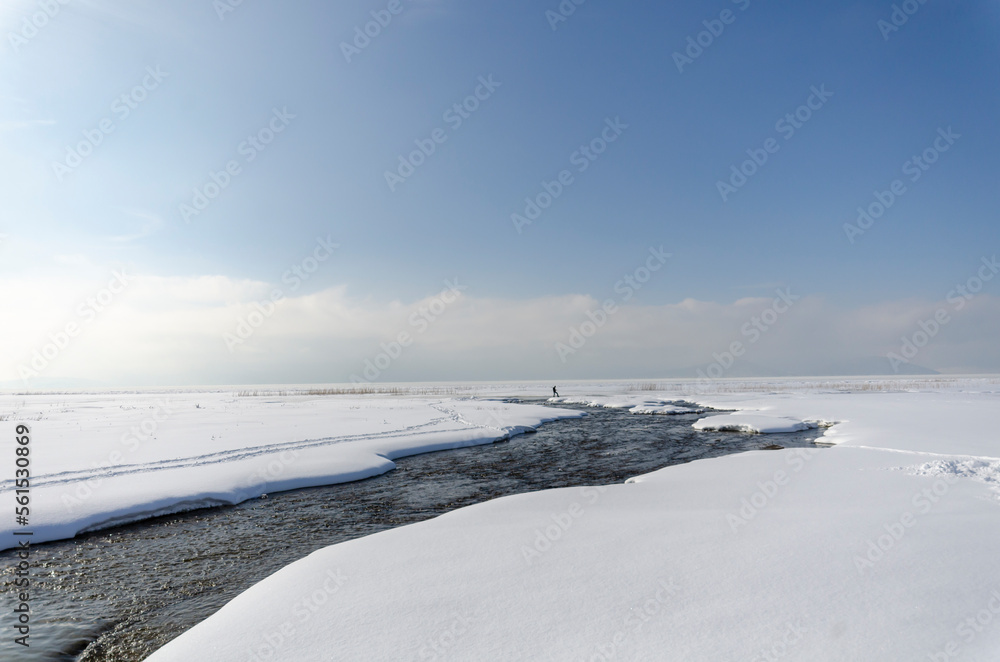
[0,0,1000,384]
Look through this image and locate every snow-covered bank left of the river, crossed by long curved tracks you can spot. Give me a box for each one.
[0,392,579,549]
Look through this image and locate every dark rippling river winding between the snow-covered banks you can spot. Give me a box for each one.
[0,406,822,662]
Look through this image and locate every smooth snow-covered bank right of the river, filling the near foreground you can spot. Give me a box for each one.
[150,388,1000,662]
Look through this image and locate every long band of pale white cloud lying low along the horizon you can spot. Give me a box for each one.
[0,275,1000,385]
